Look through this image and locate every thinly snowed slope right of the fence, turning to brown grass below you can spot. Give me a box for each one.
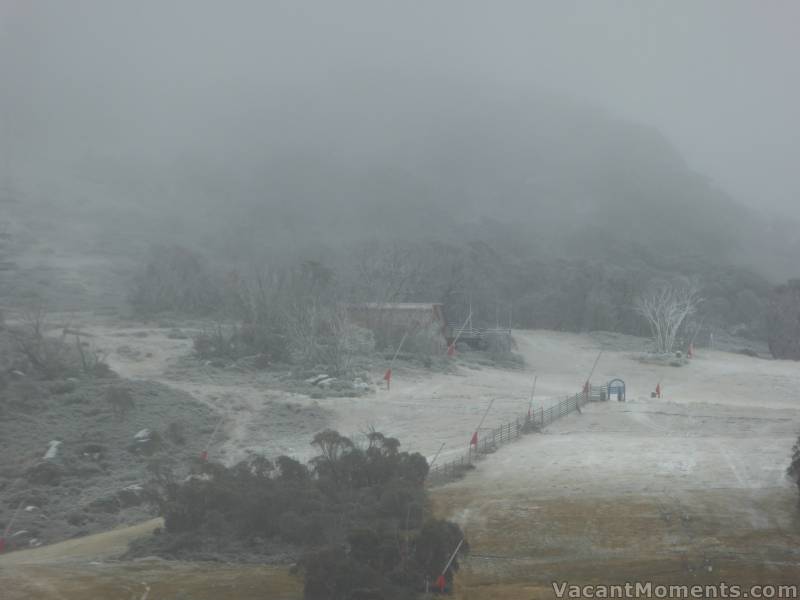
[424,332,800,598]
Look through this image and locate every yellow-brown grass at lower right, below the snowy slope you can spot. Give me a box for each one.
[434,488,800,600]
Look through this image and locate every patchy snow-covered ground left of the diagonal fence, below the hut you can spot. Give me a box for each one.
[54,315,600,462]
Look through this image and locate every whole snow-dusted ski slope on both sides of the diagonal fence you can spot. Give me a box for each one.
[3,316,800,598]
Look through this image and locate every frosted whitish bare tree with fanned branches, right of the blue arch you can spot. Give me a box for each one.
[634,282,700,353]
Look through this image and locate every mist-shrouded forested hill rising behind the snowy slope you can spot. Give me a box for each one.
[0,77,797,337]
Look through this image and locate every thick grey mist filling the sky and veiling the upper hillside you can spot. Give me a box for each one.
[0,2,800,292]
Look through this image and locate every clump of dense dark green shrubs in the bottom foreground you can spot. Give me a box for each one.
[145,430,466,600]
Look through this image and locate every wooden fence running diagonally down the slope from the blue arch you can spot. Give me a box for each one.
[428,386,608,485]
